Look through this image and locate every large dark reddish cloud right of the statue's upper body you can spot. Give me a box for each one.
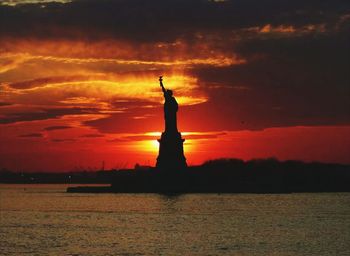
[191,24,350,130]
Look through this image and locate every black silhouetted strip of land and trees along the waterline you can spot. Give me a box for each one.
[0,158,350,193]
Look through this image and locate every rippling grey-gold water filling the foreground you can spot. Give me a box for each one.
[0,185,350,255]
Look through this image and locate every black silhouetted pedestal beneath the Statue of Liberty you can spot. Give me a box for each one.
[156,132,187,171]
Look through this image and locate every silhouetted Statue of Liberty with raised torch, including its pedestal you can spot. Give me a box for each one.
[156,77,187,170]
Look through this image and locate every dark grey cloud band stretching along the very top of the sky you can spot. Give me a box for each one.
[0,0,350,42]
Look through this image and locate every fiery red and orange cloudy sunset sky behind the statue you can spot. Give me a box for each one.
[0,0,350,171]
